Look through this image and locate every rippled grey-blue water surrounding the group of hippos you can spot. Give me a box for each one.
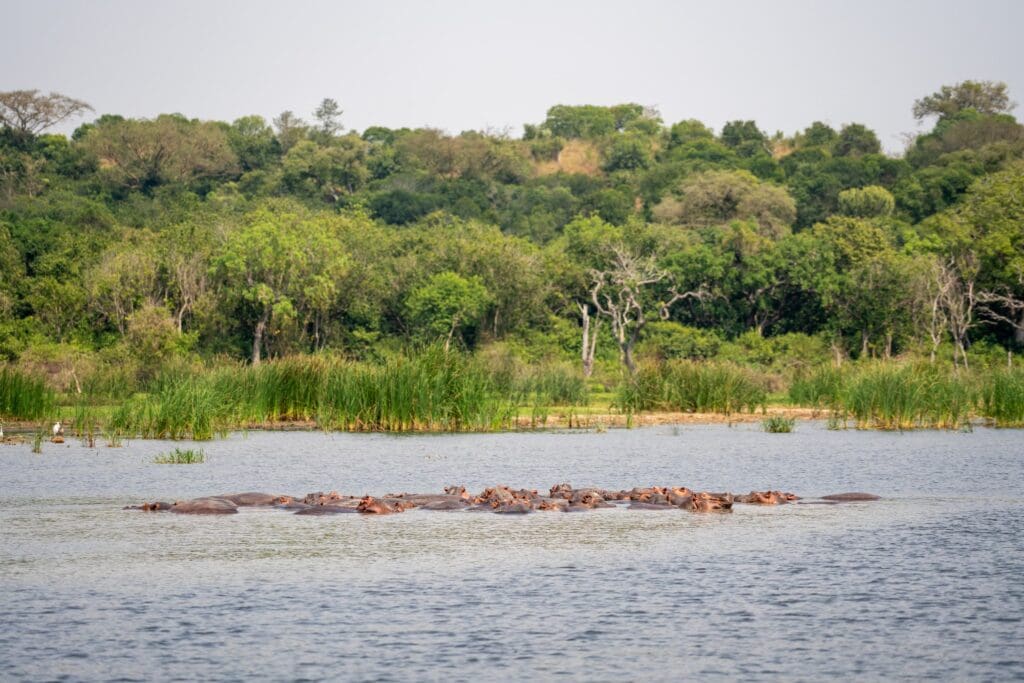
[0,423,1024,681]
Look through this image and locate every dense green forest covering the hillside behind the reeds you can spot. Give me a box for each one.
[0,81,1024,389]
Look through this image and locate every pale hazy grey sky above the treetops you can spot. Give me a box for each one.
[0,0,1024,150]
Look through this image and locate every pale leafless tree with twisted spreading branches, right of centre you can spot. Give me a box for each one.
[590,247,708,375]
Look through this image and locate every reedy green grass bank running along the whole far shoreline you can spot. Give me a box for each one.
[0,350,1024,444]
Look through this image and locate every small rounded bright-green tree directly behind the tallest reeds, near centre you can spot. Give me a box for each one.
[406,270,492,352]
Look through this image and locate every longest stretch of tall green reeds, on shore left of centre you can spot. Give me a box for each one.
[112,350,515,439]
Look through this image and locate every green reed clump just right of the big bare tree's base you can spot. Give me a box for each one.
[615,360,768,415]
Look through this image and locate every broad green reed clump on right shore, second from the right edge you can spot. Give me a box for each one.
[840,364,976,429]
